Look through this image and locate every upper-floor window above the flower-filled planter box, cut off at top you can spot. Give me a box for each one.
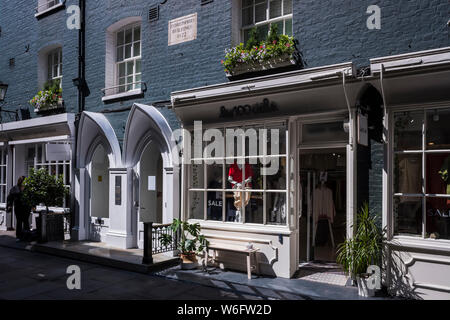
[241,0,292,43]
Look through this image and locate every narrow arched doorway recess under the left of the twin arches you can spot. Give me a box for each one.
[88,144,109,242]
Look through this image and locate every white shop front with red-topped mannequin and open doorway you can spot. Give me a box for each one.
[172,63,364,278]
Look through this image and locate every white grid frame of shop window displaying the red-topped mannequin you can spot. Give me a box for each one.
[184,119,291,227]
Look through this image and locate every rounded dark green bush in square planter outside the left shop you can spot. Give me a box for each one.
[23,168,69,242]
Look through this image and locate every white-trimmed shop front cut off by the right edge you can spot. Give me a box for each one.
[371,48,450,299]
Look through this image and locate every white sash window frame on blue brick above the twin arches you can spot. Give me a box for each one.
[114,22,142,94]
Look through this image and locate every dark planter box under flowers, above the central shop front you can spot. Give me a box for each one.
[226,52,303,81]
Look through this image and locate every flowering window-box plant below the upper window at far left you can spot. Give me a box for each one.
[29,79,64,116]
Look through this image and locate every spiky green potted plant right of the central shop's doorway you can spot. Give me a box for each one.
[336,203,383,297]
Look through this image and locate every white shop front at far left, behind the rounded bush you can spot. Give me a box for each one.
[0,113,75,230]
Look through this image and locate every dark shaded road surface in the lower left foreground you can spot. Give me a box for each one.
[0,248,265,300]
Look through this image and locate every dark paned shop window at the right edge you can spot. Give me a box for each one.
[393,109,450,239]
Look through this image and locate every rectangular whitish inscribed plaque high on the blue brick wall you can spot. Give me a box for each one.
[169,13,197,46]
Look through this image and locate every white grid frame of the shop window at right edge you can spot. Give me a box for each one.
[387,105,450,242]
